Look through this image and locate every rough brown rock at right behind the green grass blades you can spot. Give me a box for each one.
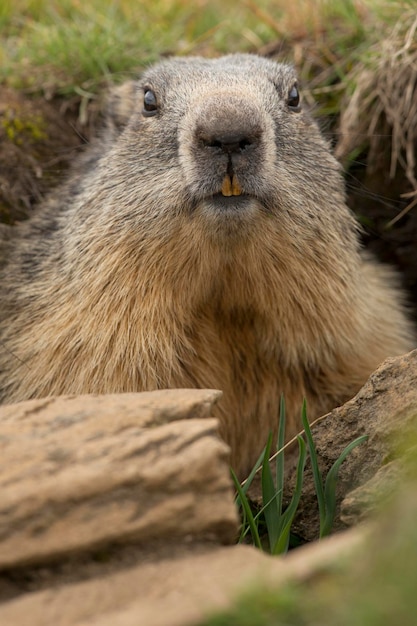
[280,350,417,540]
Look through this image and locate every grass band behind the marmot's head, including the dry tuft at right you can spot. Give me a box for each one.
[0,0,417,198]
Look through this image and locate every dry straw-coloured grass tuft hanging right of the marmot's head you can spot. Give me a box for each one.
[336,6,417,219]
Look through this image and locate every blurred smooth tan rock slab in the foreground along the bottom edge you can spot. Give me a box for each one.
[0,529,367,626]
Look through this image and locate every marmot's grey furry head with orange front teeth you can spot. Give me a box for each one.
[97,54,353,247]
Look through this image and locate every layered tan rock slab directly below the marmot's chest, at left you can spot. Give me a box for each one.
[0,390,237,570]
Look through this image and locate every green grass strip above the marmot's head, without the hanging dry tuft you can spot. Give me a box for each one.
[0,0,413,100]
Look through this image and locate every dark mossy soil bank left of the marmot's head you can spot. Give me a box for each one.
[0,87,96,224]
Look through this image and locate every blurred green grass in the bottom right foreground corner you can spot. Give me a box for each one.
[200,448,417,626]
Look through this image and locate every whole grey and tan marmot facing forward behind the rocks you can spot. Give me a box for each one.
[0,54,415,475]
